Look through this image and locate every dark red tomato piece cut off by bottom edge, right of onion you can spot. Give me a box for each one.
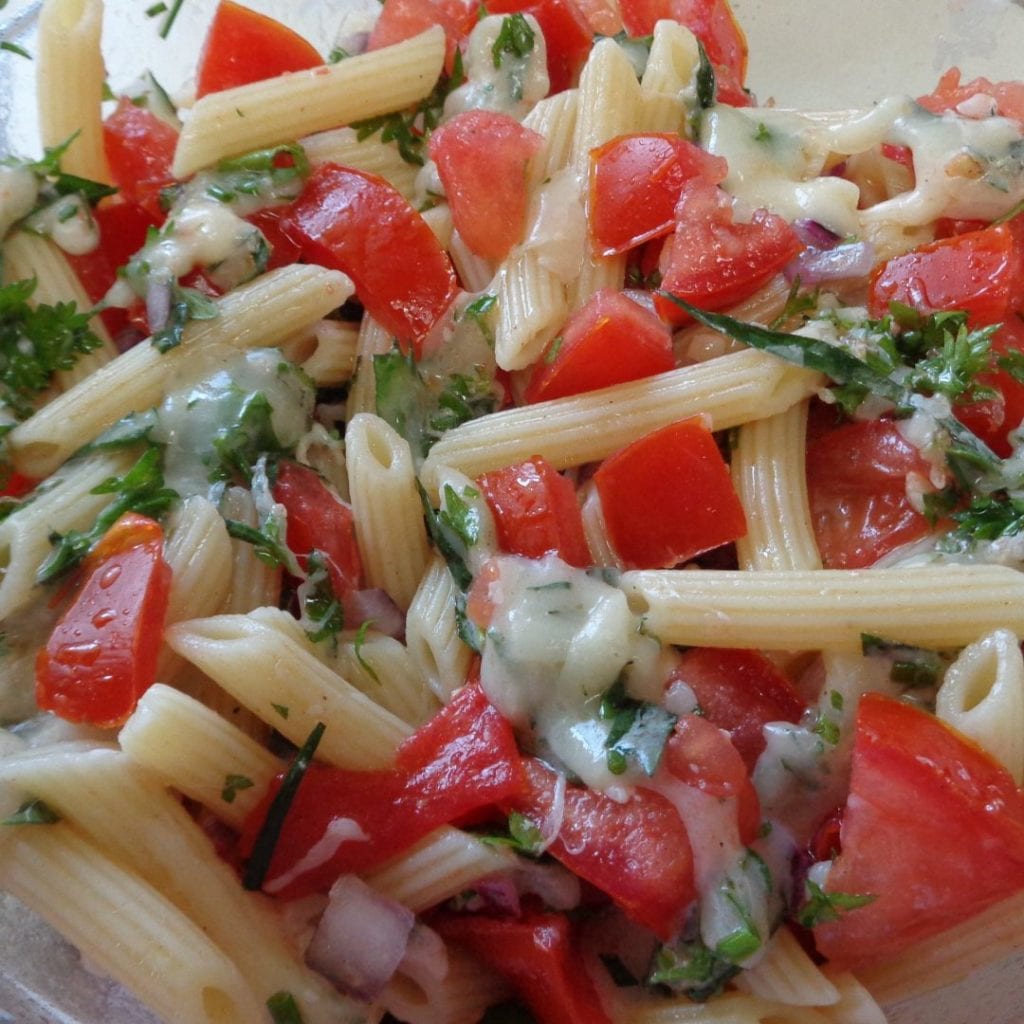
[430,913,611,1024]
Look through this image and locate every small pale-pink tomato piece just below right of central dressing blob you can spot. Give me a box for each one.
[663,715,761,844]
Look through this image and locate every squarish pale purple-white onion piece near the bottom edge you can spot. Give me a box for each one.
[306,874,416,1001]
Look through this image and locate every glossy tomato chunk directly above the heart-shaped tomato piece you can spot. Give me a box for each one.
[589,134,729,256]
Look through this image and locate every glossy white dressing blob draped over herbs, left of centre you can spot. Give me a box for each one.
[152,348,314,501]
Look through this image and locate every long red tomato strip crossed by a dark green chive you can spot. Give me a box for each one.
[242,686,522,898]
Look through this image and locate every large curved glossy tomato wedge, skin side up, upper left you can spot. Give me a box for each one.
[282,164,456,355]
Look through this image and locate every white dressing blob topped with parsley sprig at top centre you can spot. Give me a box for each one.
[444,14,550,121]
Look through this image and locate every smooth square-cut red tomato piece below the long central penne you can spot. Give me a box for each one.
[594,419,746,569]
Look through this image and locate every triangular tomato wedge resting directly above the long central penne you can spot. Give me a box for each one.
[524,288,676,401]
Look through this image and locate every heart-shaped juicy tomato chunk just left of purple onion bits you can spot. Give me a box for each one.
[656,178,801,325]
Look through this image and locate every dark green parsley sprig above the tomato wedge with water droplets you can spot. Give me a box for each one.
[36,445,178,583]
